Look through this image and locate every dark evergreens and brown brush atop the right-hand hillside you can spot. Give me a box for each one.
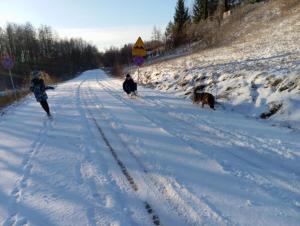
[165,0,263,48]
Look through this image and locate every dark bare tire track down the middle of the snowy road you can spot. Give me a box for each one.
[79,81,162,226]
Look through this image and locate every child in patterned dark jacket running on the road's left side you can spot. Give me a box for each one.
[30,71,54,117]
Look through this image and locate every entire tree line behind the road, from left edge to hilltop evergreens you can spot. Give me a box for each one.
[0,0,261,85]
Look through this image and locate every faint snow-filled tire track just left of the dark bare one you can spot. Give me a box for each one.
[75,79,129,226]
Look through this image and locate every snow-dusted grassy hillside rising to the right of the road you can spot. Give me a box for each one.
[134,1,300,128]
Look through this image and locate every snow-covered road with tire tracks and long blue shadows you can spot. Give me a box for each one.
[0,70,300,226]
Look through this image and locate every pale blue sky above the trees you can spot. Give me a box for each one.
[0,0,192,50]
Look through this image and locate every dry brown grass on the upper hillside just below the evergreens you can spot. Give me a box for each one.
[188,0,300,51]
